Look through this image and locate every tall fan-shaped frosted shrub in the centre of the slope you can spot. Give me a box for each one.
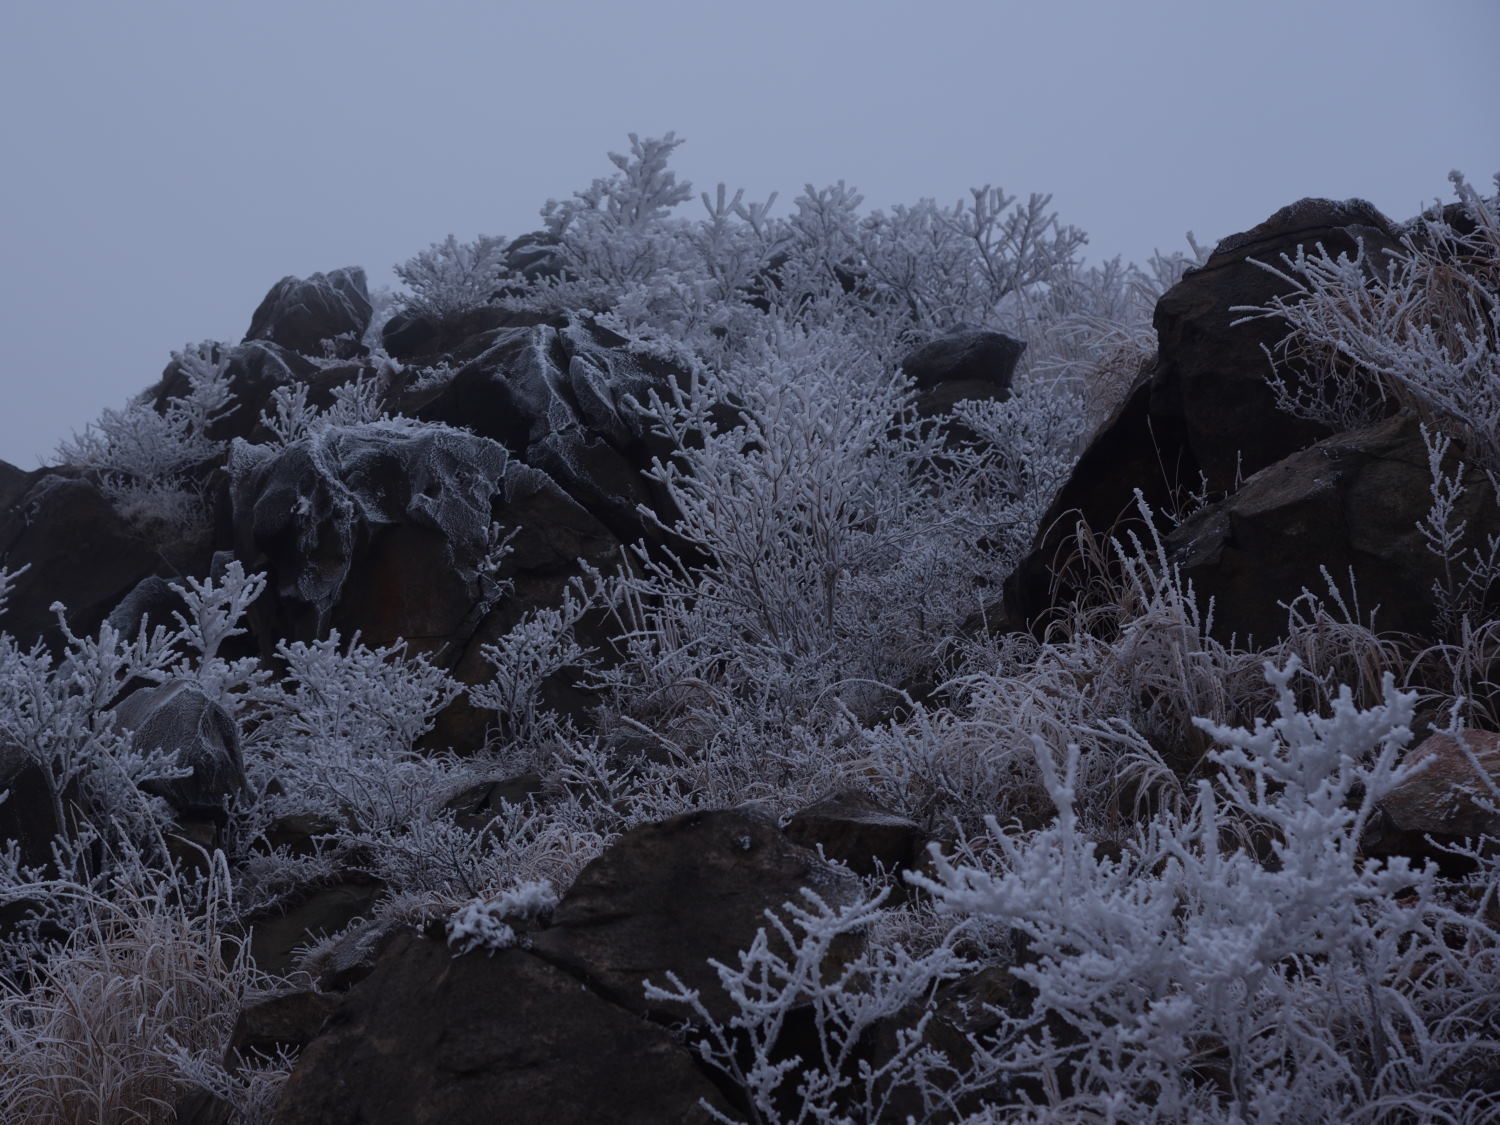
[591,325,957,732]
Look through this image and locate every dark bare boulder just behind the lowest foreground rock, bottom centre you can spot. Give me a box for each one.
[533,809,858,1019]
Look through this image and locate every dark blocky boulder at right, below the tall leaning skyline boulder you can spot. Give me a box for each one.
[1167,417,1500,645]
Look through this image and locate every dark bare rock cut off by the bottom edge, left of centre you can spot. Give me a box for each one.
[272,932,729,1125]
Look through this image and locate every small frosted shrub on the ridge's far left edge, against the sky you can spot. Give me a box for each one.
[57,342,234,540]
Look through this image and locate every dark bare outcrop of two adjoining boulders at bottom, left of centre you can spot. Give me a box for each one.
[276,809,858,1125]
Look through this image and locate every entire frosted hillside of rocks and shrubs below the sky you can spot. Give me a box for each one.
[0,145,1500,1125]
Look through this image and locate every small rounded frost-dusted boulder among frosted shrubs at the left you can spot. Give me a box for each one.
[114,680,245,816]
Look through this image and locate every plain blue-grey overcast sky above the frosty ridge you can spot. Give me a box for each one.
[0,0,1500,468]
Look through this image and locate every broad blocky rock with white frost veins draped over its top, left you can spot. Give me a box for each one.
[231,423,615,654]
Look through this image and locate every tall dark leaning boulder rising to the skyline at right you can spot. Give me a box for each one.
[1005,200,1397,639]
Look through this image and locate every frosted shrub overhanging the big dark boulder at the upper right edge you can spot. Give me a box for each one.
[1236,173,1500,470]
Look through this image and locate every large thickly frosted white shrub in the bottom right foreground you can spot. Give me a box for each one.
[911,662,1500,1122]
